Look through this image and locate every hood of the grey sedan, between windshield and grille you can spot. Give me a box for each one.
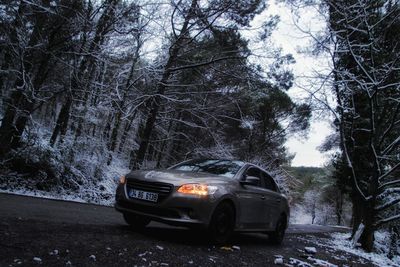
[126,170,233,186]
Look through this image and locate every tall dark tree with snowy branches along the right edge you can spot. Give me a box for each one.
[284,0,400,251]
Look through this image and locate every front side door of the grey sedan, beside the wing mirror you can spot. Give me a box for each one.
[237,166,267,229]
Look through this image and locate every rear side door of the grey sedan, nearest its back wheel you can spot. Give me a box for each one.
[261,171,283,230]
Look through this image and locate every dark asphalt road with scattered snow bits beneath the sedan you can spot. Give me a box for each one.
[0,194,373,266]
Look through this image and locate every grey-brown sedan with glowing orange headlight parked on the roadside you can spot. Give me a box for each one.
[115,159,290,244]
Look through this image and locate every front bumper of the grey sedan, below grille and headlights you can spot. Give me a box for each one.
[114,185,216,230]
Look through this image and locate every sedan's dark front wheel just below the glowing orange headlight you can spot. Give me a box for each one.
[208,202,235,245]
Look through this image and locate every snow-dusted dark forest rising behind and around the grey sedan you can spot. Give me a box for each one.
[0,0,400,260]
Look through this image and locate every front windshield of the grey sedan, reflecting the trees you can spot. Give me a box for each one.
[171,159,244,178]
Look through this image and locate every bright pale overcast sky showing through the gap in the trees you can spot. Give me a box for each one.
[252,0,332,167]
